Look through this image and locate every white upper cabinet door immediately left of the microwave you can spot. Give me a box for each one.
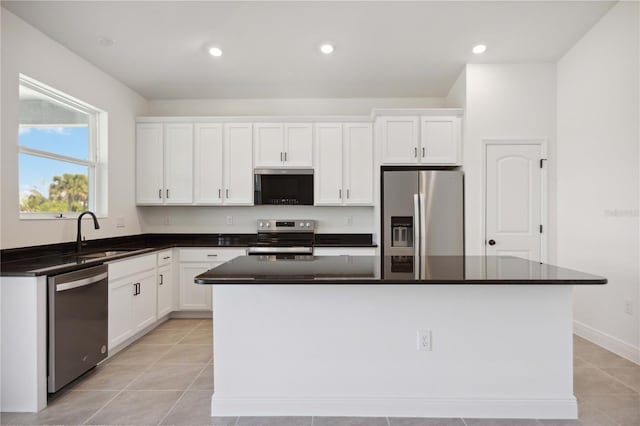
[223,123,253,206]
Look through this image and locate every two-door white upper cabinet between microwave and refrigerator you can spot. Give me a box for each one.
[315,123,373,206]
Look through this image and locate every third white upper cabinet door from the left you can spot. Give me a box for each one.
[194,123,224,204]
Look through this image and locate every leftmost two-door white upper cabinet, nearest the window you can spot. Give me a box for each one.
[136,123,193,204]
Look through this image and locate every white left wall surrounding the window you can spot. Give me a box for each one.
[0,9,147,248]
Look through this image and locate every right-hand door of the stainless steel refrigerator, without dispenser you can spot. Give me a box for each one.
[419,170,464,256]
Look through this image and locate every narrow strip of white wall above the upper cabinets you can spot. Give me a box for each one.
[149,98,444,116]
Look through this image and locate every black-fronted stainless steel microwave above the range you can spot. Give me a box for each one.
[253,169,313,206]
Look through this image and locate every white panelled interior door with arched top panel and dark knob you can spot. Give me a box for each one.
[485,144,543,261]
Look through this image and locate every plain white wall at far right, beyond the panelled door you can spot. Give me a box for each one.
[558,2,640,362]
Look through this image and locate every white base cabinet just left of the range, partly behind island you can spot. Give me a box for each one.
[178,247,246,311]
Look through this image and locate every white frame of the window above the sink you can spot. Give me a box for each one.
[16,74,108,220]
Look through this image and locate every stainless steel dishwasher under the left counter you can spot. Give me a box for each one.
[47,265,109,393]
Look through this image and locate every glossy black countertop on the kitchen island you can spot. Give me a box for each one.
[195,256,607,285]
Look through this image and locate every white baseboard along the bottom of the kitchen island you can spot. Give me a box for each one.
[211,394,578,419]
